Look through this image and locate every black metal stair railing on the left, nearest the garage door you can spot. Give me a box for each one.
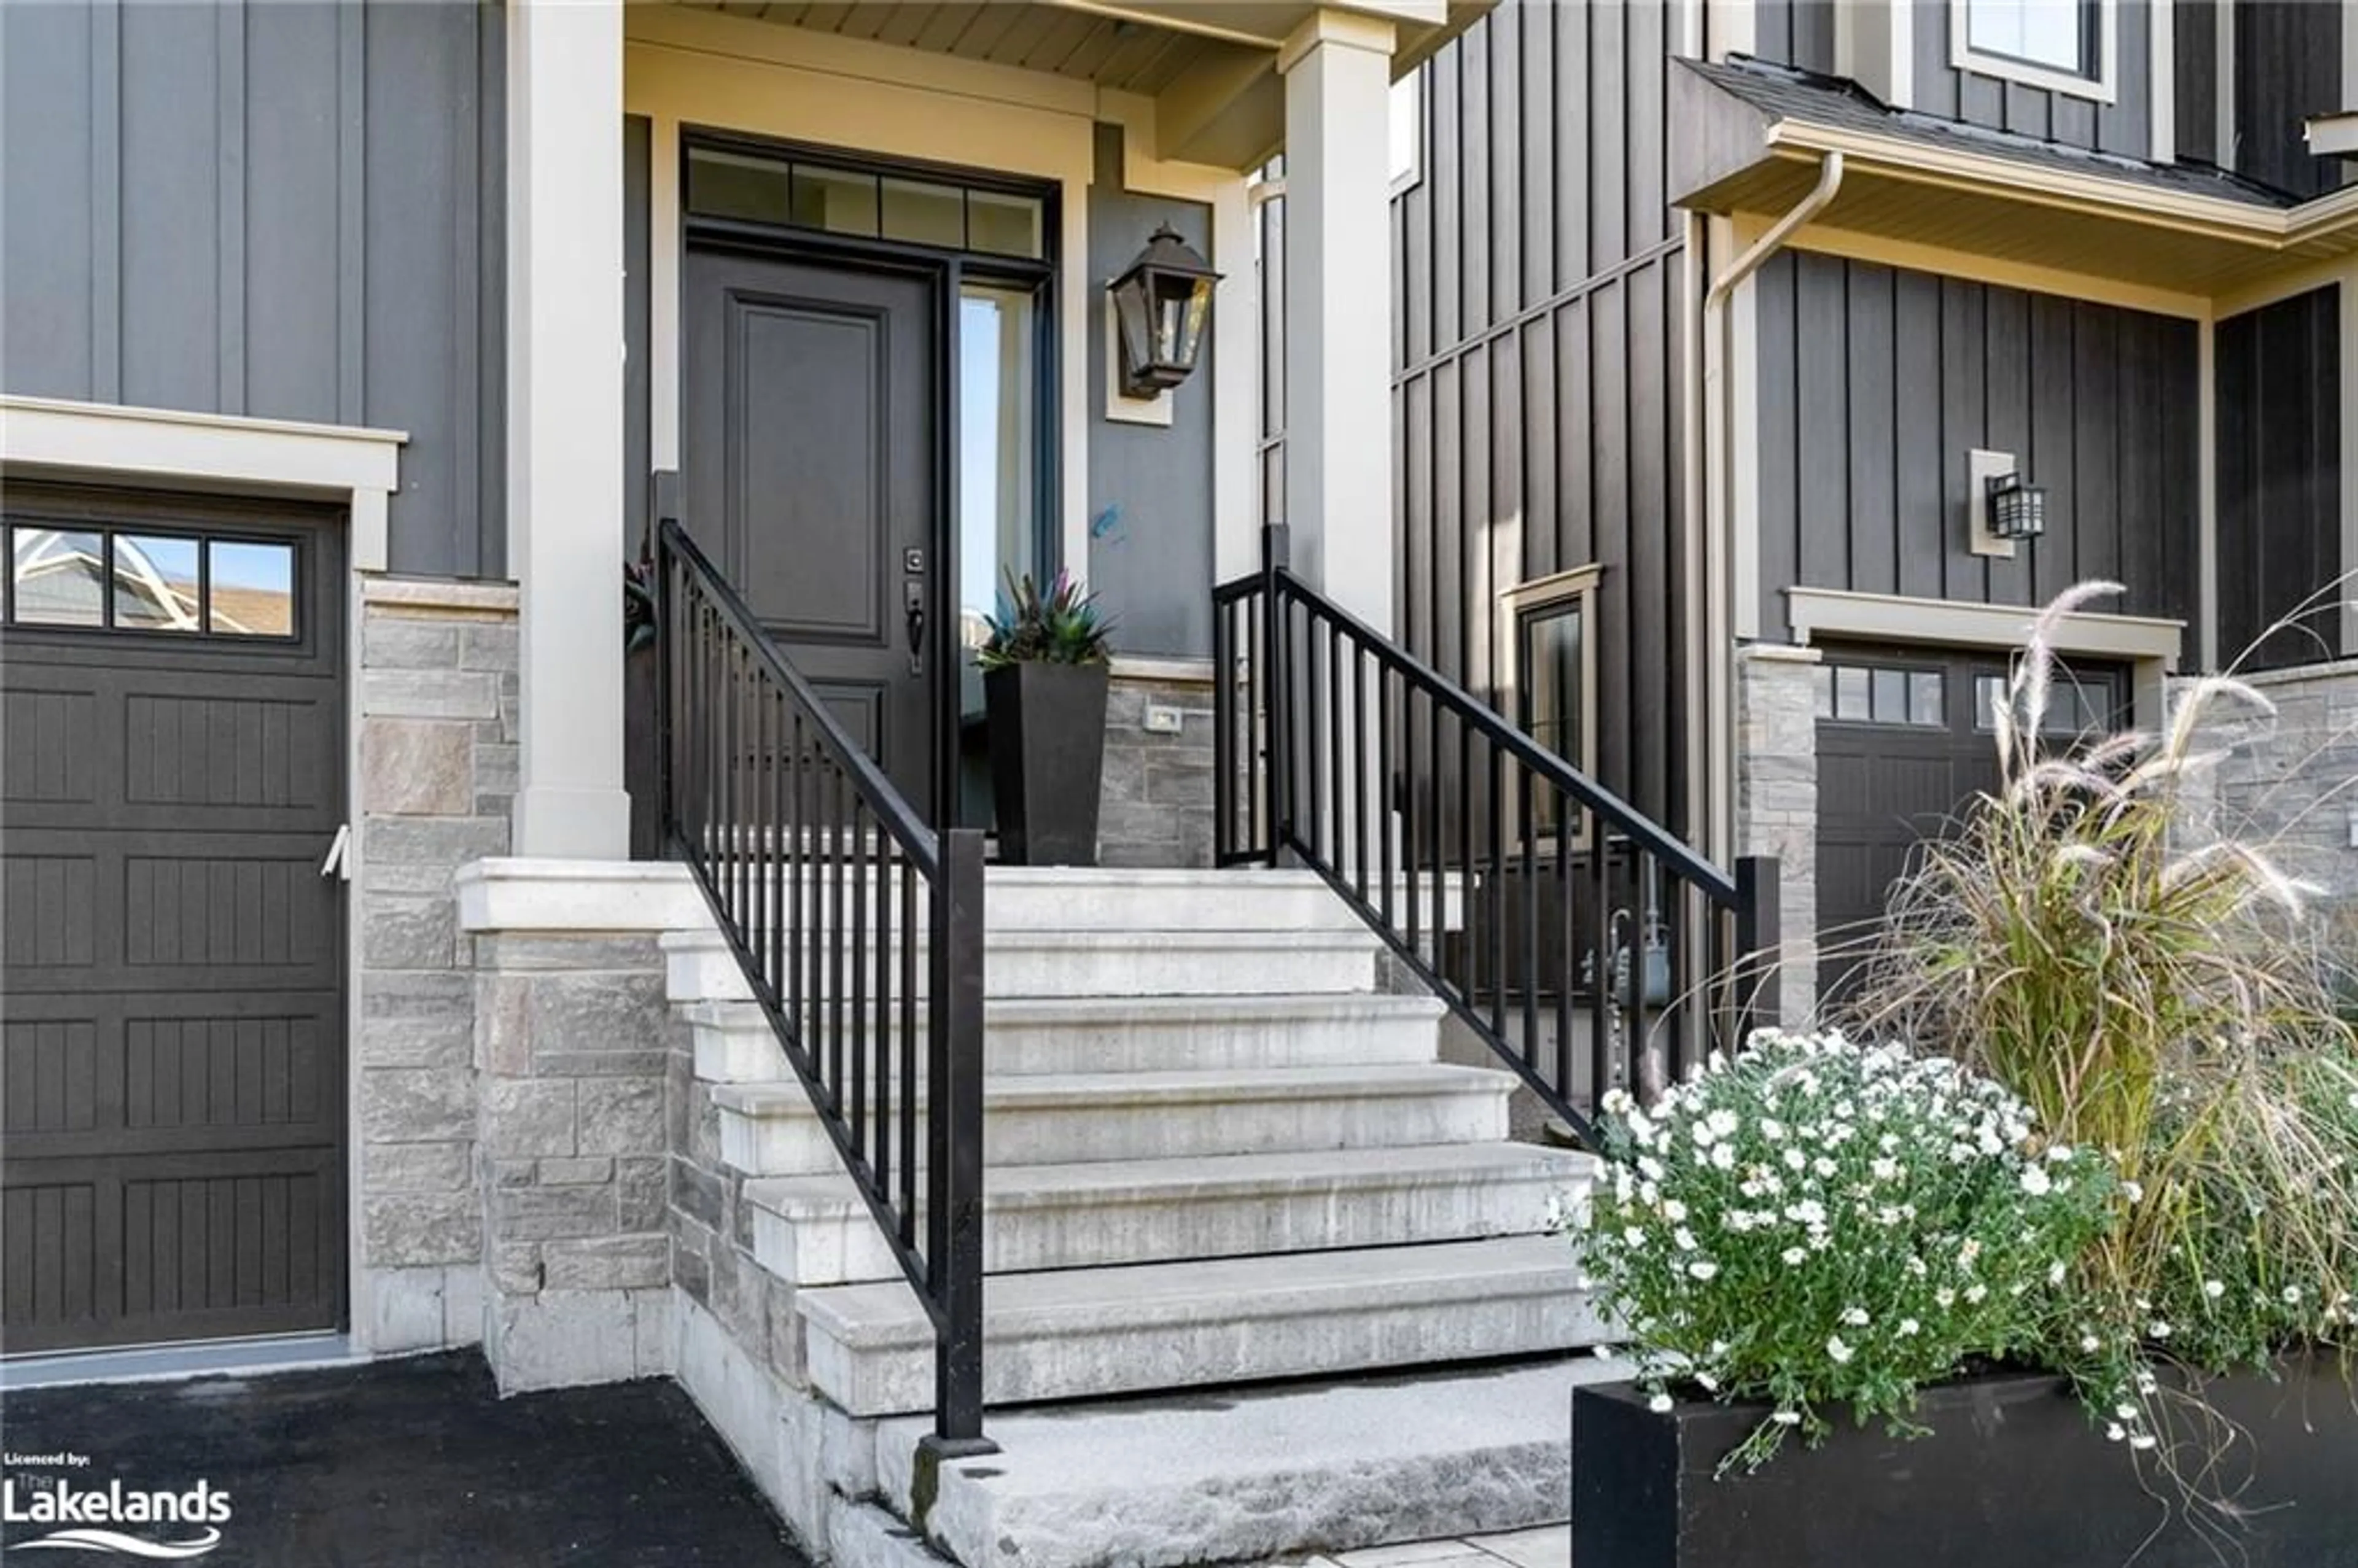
[656,519,990,1455]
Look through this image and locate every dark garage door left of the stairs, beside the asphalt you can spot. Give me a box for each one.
[0,486,344,1356]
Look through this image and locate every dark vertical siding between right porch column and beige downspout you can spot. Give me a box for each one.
[1391,0,1688,830]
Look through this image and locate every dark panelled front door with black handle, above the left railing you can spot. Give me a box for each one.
[684,250,955,813]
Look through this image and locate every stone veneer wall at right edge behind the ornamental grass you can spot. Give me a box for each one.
[2176,660,2358,903]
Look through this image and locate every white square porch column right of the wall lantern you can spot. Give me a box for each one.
[1278,12,1398,632]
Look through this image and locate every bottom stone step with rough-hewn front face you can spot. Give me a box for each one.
[877,1356,1629,1568]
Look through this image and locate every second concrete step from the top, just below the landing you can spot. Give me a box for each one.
[663,926,1377,1002]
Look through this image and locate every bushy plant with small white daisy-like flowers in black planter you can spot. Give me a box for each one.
[1573,1030,2117,1469]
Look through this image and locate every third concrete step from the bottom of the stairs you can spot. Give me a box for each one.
[745,1144,1597,1285]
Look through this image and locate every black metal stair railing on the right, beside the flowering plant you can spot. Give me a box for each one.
[1212,526,1778,1139]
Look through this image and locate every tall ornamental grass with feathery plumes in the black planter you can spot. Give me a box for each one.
[1849,583,2358,1434]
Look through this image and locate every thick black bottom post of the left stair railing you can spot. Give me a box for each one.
[924,828,997,1462]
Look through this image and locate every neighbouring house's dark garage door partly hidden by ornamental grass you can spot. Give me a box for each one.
[1816,648,2130,1004]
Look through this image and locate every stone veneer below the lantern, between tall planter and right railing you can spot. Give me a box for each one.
[1097,658,1212,866]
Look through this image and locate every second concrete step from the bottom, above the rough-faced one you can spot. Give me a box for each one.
[795,1235,1603,1415]
